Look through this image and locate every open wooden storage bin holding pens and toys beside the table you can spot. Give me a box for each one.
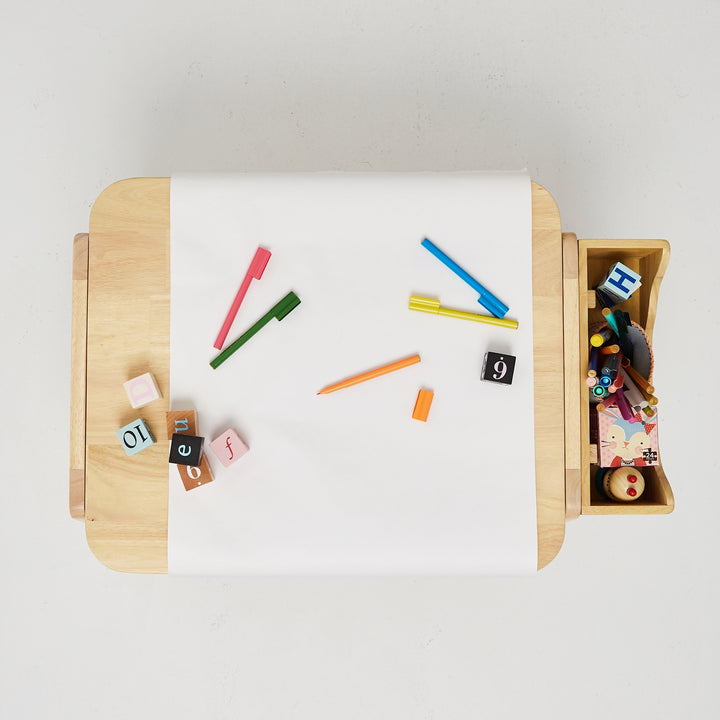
[569,240,675,515]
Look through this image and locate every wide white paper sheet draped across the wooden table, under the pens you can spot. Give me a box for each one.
[168,172,542,575]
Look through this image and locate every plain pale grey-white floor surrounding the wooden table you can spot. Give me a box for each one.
[0,0,720,720]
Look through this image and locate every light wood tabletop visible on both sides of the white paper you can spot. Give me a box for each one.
[70,178,566,573]
